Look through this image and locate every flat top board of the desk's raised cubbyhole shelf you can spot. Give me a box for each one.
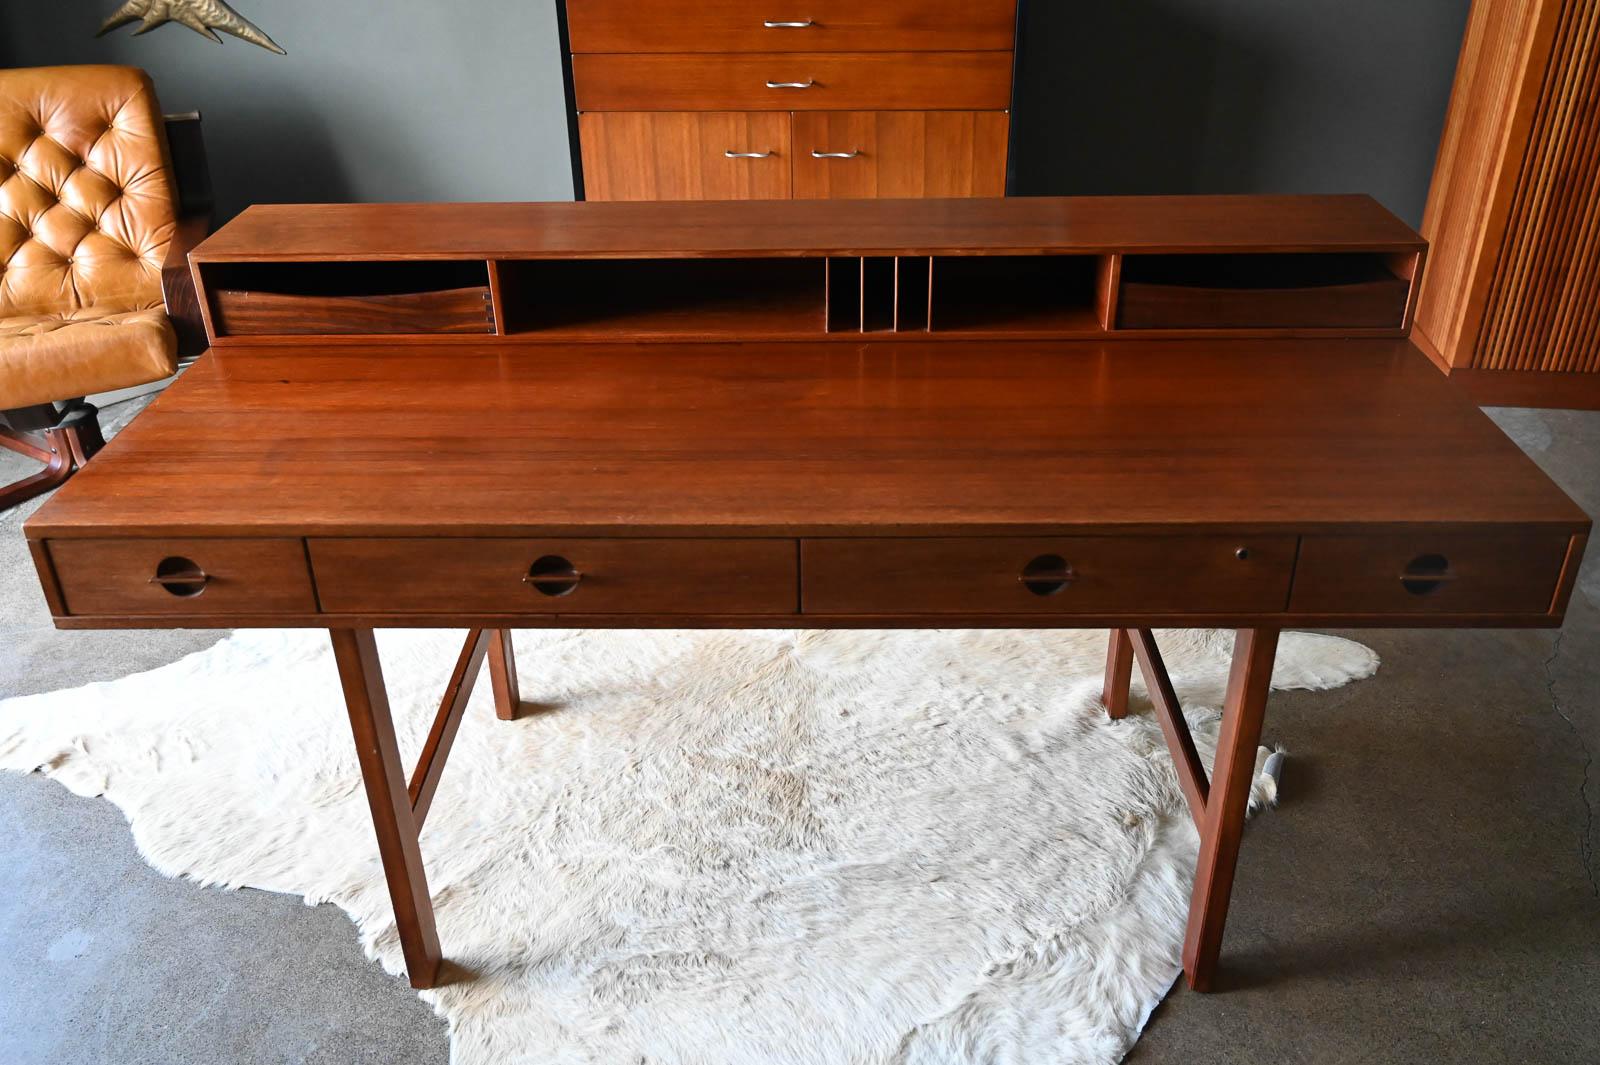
[192,195,1422,262]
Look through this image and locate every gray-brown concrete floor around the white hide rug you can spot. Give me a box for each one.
[0,393,1600,1065]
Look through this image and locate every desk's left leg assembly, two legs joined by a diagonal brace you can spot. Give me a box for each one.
[328,628,520,988]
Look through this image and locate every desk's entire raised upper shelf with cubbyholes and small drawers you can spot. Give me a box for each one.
[192,197,1426,344]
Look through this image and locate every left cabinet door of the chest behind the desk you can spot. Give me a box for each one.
[578,112,790,200]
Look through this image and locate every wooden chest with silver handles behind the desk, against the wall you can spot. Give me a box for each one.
[565,0,1018,200]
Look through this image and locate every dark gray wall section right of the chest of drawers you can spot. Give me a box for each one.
[1013,0,1470,225]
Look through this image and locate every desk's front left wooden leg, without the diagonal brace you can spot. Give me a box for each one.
[328,628,443,988]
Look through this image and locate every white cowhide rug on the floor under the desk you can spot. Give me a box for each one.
[0,630,1378,1065]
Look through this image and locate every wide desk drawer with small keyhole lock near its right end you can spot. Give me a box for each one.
[800,536,1294,614]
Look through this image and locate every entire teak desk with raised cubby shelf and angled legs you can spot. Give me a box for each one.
[26,197,1589,988]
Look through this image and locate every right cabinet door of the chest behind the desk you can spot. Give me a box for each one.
[794,110,1010,200]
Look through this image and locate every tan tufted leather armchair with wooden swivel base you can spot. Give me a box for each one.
[0,66,210,510]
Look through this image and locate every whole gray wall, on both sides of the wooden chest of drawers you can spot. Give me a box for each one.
[0,0,1469,224]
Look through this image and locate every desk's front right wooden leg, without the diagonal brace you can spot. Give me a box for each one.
[1184,628,1278,991]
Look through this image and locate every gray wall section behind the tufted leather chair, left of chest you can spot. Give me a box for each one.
[0,0,573,217]
